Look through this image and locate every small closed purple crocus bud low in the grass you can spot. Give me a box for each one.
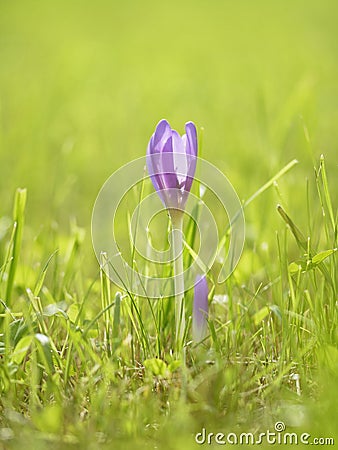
[192,275,208,342]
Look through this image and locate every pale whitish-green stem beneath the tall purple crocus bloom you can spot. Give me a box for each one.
[170,210,185,353]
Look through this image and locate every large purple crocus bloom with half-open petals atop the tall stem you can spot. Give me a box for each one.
[147,119,197,210]
